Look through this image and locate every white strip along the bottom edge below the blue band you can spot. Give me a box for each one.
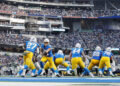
[0,82,120,86]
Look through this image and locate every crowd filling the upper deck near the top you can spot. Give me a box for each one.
[0,3,120,18]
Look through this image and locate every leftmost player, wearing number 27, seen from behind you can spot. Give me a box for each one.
[19,36,39,77]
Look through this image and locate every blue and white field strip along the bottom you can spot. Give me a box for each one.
[0,77,120,86]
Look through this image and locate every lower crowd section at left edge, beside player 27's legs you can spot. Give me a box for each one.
[0,52,23,75]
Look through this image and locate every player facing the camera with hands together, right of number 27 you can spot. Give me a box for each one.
[38,38,60,77]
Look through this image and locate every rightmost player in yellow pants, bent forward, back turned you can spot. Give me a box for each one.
[99,47,114,77]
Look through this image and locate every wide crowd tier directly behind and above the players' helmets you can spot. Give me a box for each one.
[0,31,120,49]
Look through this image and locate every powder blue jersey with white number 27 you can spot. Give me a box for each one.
[26,41,39,53]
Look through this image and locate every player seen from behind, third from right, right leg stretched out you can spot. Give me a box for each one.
[70,43,94,77]
